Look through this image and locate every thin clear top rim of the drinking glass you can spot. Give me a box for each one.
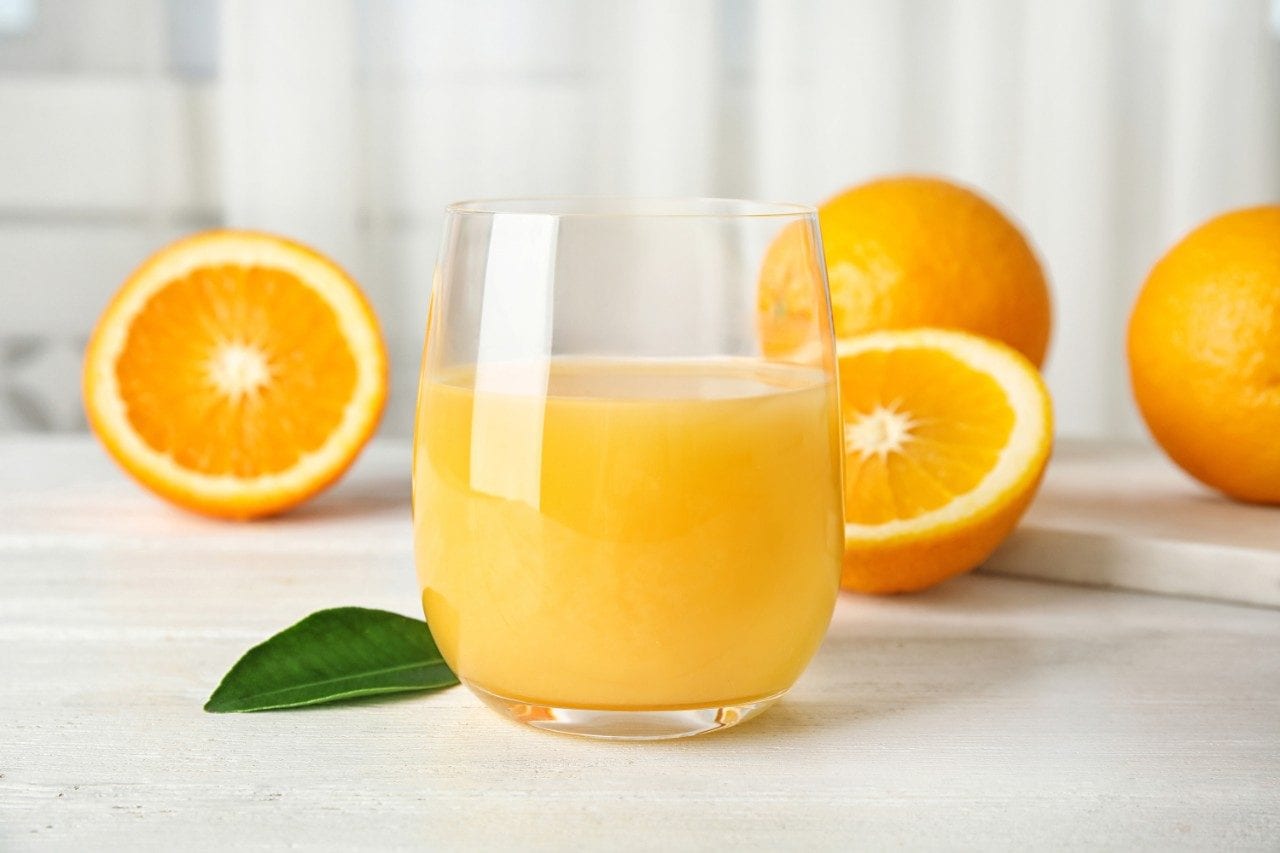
[444,196,818,219]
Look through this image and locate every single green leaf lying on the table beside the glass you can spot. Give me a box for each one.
[205,607,458,713]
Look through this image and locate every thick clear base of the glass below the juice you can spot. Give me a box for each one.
[463,680,786,740]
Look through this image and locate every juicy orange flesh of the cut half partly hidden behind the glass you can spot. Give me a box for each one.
[840,348,1014,524]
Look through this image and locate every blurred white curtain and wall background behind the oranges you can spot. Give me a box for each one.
[0,0,1280,437]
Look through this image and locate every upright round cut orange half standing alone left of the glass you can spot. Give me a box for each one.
[84,231,387,519]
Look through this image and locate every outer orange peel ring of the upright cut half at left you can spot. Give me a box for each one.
[82,229,389,521]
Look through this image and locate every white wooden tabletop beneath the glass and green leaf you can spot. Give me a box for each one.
[0,439,1280,850]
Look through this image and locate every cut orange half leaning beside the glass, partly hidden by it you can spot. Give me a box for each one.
[836,329,1052,593]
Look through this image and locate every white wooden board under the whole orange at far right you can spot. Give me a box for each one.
[983,442,1280,607]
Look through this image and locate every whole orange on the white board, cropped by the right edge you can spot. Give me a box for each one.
[1129,205,1280,503]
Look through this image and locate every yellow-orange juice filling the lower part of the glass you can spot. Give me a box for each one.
[413,360,844,710]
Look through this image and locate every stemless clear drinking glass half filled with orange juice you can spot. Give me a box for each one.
[413,199,844,739]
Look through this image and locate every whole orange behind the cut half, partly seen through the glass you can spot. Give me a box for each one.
[759,177,1052,366]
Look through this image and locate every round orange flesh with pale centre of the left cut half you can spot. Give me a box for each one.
[115,265,357,478]
